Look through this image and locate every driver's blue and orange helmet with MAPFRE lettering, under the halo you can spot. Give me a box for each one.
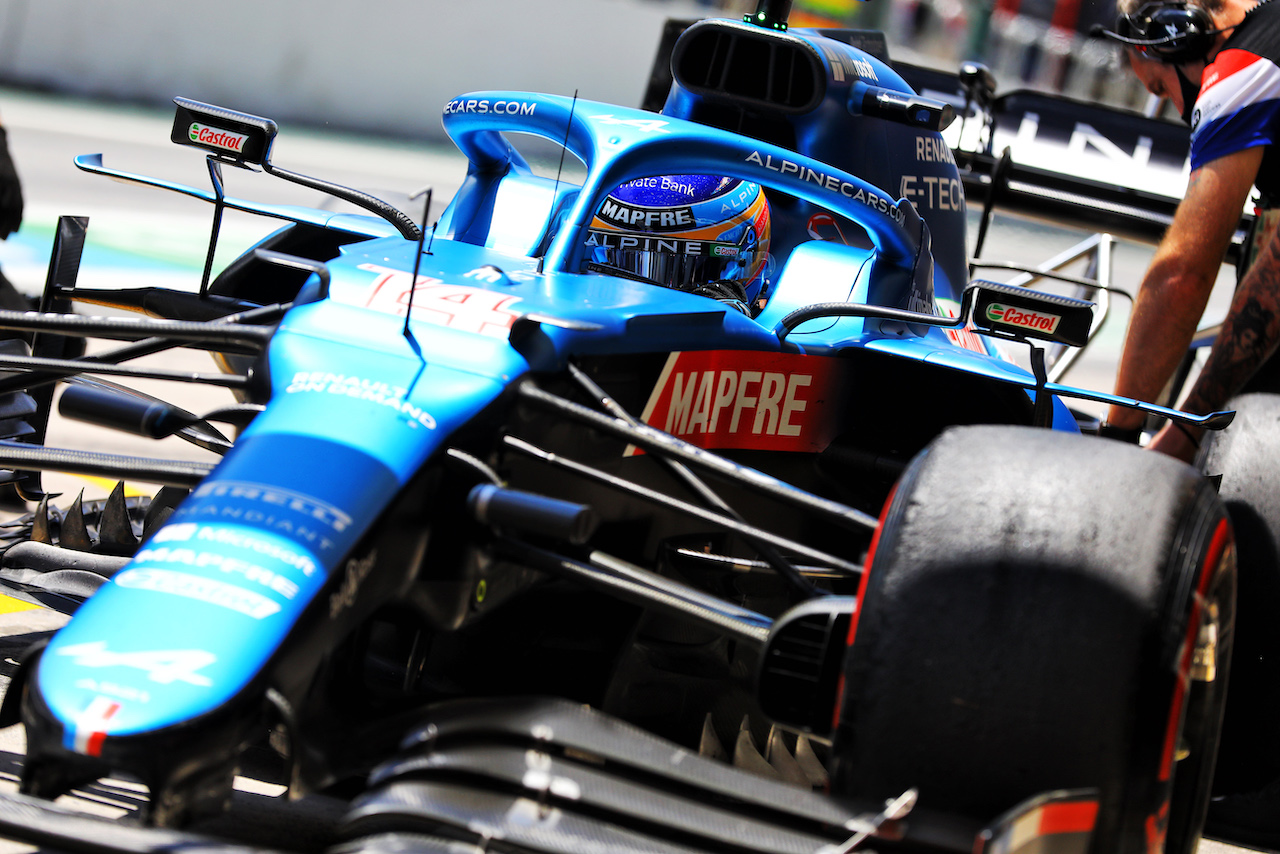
[586,175,769,314]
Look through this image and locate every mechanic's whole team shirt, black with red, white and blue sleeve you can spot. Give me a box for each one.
[1190,0,1280,198]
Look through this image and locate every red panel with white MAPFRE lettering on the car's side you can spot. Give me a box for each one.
[627,350,847,455]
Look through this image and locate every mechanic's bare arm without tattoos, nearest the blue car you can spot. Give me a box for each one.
[1107,146,1265,429]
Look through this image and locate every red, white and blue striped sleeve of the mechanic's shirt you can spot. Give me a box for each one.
[1192,50,1280,170]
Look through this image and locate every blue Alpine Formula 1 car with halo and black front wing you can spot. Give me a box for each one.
[0,5,1235,853]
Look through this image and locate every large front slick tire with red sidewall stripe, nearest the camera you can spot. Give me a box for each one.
[833,426,1235,854]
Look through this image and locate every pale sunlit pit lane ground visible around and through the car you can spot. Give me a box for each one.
[0,88,1240,854]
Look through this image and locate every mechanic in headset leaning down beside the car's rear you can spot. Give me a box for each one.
[1098,0,1280,461]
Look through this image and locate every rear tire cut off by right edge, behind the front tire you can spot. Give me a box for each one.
[1201,394,1280,795]
